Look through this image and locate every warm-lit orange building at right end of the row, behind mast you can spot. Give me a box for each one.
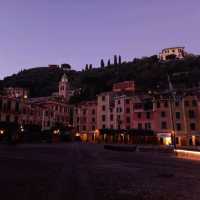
[154,94,200,146]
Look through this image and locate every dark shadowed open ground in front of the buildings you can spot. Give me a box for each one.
[0,144,200,200]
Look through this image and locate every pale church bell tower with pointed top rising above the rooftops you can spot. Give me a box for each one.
[59,74,70,101]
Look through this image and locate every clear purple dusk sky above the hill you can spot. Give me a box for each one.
[0,0,200,78]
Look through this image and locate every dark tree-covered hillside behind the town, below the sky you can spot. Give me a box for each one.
[0,56,200,102]
